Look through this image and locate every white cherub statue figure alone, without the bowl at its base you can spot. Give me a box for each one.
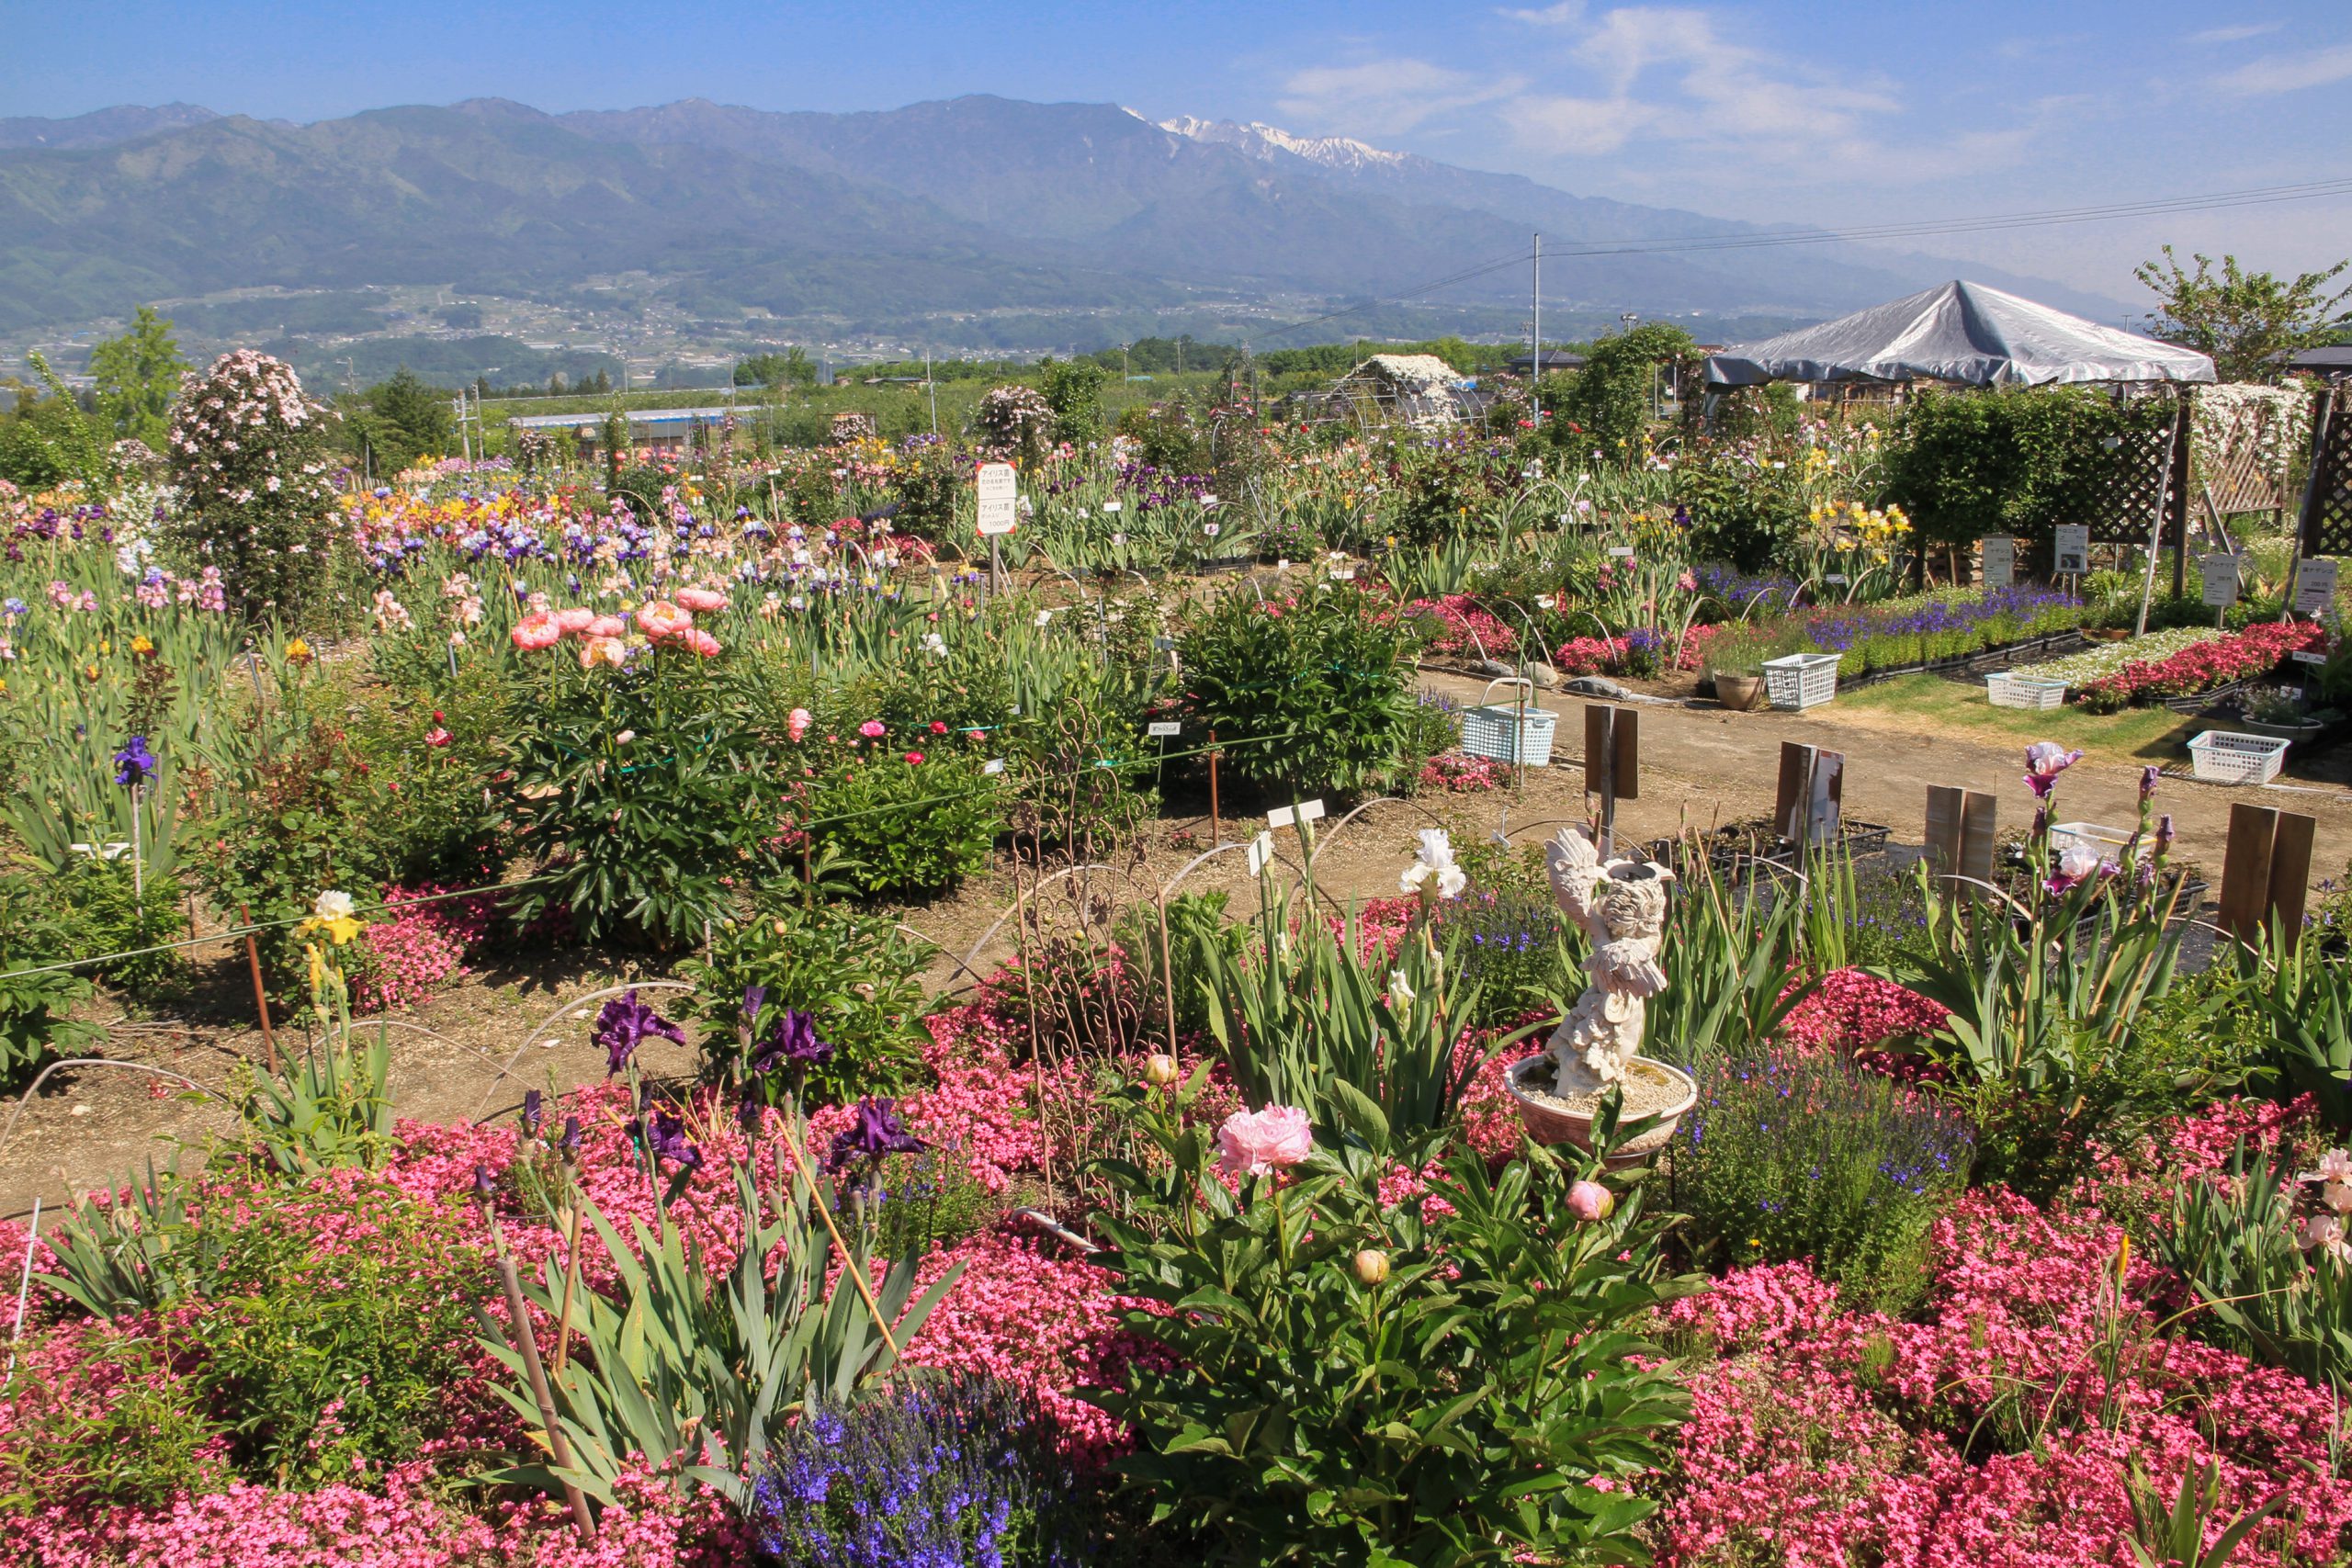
[1545,828,1675,1098]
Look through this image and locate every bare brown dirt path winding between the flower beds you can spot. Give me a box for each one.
[0,691,2352,1223]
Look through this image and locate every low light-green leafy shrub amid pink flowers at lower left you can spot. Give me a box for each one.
[193,1182,487,1485]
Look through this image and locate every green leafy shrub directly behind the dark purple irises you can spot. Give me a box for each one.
[680,888,932,1105]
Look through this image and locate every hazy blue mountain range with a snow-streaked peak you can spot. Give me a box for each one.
[0,96,2117,345]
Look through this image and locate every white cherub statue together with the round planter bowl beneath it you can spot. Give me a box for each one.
[1505,828,1698,1166]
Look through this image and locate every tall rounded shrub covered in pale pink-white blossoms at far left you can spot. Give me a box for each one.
[169,348,334,623]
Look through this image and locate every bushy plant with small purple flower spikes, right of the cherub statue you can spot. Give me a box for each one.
[1672,1051,1973,1314]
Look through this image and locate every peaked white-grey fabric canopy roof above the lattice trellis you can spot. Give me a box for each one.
[1708,280,2213,390]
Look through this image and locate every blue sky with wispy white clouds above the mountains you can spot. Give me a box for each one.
[0,0,2352,299]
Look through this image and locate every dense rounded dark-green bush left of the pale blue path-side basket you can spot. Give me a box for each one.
[1179,588,1414,799]
